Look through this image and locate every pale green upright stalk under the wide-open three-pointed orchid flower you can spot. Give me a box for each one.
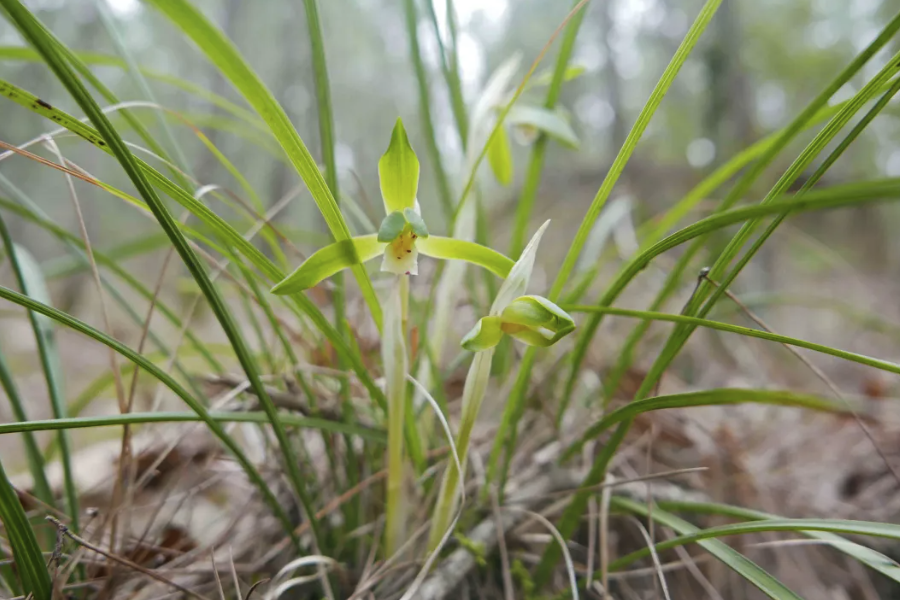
[381,275,409,557]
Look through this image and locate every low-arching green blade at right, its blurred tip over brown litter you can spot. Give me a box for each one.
[562,389,847,460]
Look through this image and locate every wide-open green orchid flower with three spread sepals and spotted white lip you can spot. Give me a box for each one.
[272,119,513,294]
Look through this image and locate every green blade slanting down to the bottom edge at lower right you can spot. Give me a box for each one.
[609,497,802,600]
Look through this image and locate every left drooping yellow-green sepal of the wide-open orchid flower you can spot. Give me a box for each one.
[272,234,385,294]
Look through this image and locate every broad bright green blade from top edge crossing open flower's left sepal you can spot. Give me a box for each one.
[142,0,381,329]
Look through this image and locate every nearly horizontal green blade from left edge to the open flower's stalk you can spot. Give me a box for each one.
[0,411,387,444]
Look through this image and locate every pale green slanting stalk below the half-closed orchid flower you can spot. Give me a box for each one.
[428,348,494,552]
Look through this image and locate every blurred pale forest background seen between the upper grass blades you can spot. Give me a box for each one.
[0,0,900,364]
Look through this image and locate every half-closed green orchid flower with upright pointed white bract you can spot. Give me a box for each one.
[462,221,575,352]
